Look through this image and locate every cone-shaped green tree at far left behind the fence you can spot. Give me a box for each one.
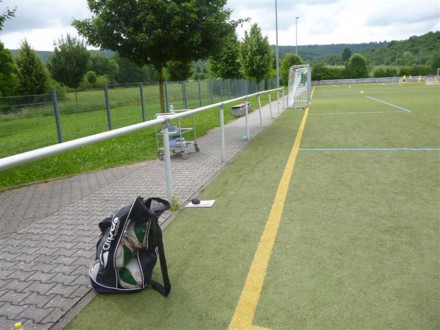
[15,40,50,95]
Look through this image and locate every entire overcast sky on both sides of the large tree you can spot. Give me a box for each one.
[0,0,440,50]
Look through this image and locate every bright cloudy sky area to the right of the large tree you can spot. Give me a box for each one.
[228,0,440,45]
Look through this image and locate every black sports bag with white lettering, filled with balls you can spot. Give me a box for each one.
[89,197,171,297]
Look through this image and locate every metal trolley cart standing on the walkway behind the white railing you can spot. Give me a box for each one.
[155,110,200,160]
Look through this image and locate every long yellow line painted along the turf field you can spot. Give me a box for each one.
[229,94,309,330]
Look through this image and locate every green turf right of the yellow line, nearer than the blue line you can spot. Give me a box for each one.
[255,151,440,329]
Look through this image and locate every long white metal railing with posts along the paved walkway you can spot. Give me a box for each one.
[0,88,284,201]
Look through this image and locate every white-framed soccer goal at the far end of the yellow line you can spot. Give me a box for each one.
[287,64,312,109]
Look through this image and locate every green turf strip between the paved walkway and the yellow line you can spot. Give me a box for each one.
[67,104,302,329]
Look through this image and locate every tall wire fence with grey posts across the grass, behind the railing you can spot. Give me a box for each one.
[0,80,274,158]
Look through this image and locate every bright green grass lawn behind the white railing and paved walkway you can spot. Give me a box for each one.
[0,86,276,192]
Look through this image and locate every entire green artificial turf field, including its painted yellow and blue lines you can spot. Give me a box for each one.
[66,84,440,329]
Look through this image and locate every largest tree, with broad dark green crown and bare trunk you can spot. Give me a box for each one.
[73,0,235,112]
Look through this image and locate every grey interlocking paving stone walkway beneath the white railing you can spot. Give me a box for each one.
[0,101,284,330]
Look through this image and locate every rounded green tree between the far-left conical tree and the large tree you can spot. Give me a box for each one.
[48,34,90,88]
